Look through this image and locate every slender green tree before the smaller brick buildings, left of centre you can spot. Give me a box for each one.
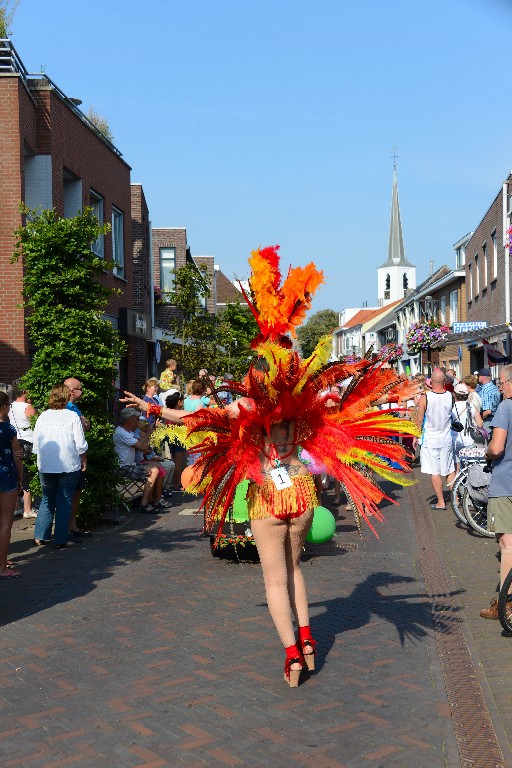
[165,264,218,379]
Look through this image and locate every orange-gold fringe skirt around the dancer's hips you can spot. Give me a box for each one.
[247,475,318,520]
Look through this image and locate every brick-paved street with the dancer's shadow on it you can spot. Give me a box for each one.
[0,475,512,768]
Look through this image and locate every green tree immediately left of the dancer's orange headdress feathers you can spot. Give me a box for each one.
[217,302,259,379]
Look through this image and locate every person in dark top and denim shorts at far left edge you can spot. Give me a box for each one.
[0,392,23,579]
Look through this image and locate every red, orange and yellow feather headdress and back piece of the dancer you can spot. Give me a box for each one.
[162,246,417,534]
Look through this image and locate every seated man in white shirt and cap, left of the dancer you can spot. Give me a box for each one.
[114,408,164,513]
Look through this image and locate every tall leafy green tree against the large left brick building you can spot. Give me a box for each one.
[13,206,124,524]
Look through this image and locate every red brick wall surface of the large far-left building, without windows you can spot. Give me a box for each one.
[0,75,140,381]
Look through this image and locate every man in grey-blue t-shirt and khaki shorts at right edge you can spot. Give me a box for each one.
[479,365,512,619]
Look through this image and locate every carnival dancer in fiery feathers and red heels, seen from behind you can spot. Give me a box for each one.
[125,246,418,687]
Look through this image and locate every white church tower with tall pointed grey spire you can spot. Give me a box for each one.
[377,162,416,307]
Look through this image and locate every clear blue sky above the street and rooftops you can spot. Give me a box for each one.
[12,0,512,310]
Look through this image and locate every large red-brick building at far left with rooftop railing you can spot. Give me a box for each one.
[0,41,151,387]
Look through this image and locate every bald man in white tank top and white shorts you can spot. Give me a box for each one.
[414,368,455,509]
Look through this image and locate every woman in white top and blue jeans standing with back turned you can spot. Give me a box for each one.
[33,384,87,549]
